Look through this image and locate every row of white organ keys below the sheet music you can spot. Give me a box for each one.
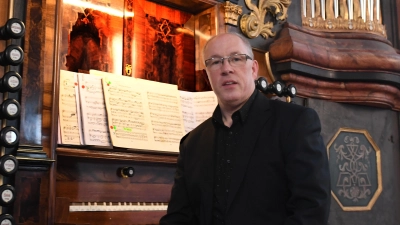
[69,202,168,212]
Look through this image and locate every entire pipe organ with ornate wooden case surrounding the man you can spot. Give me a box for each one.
[0,0,400,225]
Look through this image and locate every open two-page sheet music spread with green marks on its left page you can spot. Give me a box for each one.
[103,76,184,152]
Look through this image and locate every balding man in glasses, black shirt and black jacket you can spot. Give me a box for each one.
[160,33,330,225]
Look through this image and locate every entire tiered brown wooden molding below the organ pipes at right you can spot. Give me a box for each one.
[269,23,400,111]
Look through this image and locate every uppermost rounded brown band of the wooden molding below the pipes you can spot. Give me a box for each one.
[270,23,400,71]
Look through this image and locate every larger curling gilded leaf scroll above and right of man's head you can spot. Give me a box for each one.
[240,0,292,39]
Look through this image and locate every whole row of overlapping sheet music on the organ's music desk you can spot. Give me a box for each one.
[58,70,218,152]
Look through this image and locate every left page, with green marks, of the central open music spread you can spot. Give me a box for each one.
[102,76,153,149]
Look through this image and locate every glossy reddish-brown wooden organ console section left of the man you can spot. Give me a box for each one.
[10,0,217,225]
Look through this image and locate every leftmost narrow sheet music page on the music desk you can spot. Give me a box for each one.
[59,70,81,145]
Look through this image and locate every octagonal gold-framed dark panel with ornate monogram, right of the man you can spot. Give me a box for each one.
[327,128,382,211]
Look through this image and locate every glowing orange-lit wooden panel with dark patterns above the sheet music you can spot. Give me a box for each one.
[59,0,195,91]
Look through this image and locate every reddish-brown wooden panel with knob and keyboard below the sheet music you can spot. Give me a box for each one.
[54,147,176,225]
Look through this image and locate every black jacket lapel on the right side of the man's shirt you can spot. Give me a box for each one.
[227,93,271,210]
